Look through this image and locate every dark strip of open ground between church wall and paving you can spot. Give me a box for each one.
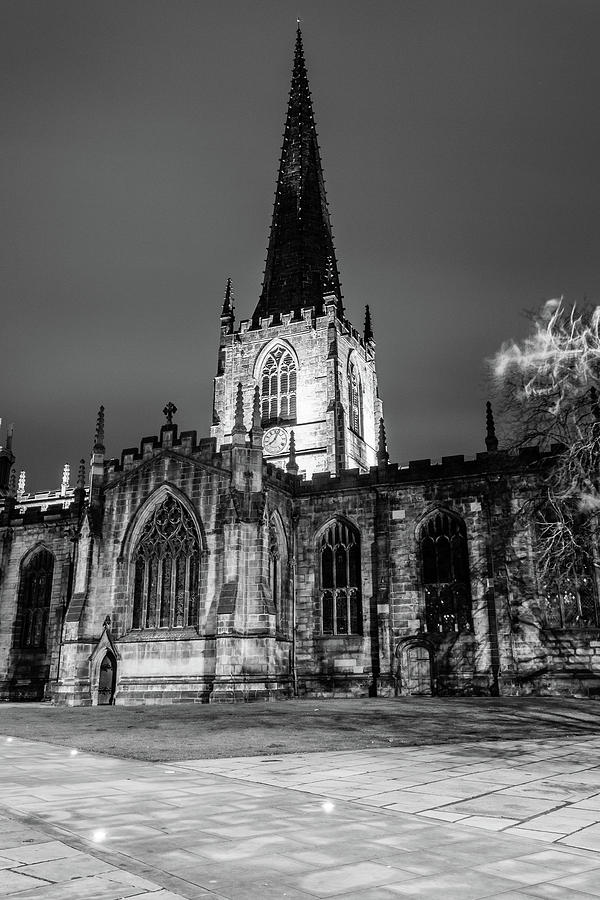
[0,697,600,760]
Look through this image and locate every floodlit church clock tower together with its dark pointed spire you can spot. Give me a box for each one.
[211,26,383,478]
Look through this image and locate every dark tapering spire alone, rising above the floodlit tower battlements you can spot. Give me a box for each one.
[253,23,343,323]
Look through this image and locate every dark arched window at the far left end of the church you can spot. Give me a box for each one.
[15,548,54,650]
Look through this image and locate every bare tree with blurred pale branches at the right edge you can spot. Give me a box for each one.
[492,300,600,621]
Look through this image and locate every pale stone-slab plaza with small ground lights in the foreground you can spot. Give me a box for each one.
[0,735,600,900]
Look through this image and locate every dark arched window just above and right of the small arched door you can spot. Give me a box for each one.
[418,511,473,633]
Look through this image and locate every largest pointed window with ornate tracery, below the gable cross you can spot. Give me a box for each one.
[132,494,200,628]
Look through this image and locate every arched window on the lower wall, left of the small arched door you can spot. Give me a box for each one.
[320,522,362,634]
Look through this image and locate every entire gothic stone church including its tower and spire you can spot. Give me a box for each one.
[0,31,600,705]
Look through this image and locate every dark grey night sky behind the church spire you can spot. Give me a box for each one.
[0,0,600,490]
